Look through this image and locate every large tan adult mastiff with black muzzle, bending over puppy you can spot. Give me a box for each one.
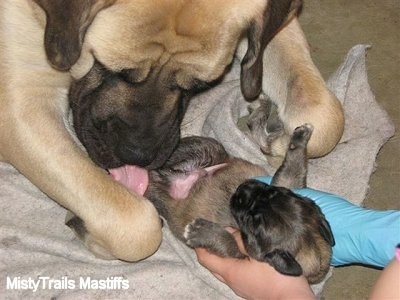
[0,0,343,261]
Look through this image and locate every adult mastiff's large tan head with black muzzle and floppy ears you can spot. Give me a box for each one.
[35,0,300,168]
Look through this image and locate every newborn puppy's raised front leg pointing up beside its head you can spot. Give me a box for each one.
[272,124,313,188]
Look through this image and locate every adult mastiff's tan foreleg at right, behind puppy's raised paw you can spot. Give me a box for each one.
[238,18,344,164]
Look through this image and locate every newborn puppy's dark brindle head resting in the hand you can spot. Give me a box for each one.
[230,180,334,282]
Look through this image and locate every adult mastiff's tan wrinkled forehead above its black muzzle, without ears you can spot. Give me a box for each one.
[72,0,268,81]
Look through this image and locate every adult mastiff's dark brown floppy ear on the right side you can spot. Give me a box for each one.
[240,0,303,101]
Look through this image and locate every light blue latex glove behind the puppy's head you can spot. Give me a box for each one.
[255,176,400,267]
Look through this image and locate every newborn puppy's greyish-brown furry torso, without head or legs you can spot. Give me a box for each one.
[150,158,266,237]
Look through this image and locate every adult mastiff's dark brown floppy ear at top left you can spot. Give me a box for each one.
[34,0,116,71]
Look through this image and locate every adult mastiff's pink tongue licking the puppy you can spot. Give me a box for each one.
[108,165,149,195]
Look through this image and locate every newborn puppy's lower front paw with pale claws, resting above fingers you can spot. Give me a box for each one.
[183,219,245,258]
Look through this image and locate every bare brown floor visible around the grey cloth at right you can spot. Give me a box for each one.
[300,0,400,300]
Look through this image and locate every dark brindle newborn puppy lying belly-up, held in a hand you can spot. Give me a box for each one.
[145,125,334,283]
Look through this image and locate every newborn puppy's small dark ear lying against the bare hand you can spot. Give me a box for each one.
[264,249,303,276]
